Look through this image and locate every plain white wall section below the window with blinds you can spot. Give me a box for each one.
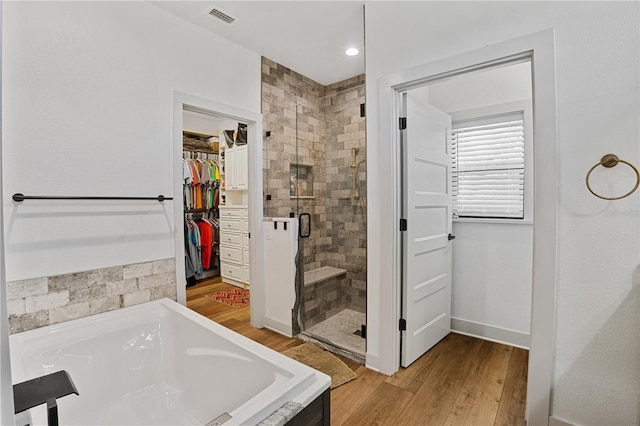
[451,222,533,340]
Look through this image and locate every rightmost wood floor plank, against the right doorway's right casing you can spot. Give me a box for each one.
[494,348,529,426]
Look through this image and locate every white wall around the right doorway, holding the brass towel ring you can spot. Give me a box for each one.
[365,2,640,424]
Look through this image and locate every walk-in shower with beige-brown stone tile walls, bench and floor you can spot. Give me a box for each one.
[262,58,367,358]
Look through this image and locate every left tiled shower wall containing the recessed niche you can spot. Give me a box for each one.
[262,57,327,270]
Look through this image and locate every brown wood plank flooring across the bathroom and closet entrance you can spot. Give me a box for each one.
[187,279,528,426]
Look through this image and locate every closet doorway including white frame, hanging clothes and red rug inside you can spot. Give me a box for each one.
[173,92,263,327]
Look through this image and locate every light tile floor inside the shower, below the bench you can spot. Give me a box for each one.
[306,309,367,357]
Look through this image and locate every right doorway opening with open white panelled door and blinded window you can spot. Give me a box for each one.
[400,59,534,367]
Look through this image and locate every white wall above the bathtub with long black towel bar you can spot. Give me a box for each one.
[2,1,260,281]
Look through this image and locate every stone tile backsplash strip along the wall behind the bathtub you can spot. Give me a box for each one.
[7,258,177,334]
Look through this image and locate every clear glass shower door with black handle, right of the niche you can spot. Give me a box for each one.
[292,85,367,360]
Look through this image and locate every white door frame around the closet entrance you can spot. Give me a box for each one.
[173,91,264,328]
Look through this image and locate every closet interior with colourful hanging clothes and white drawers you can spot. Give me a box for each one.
[182,109,249,287]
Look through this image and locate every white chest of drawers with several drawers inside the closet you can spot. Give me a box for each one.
[220,206,249,287]
